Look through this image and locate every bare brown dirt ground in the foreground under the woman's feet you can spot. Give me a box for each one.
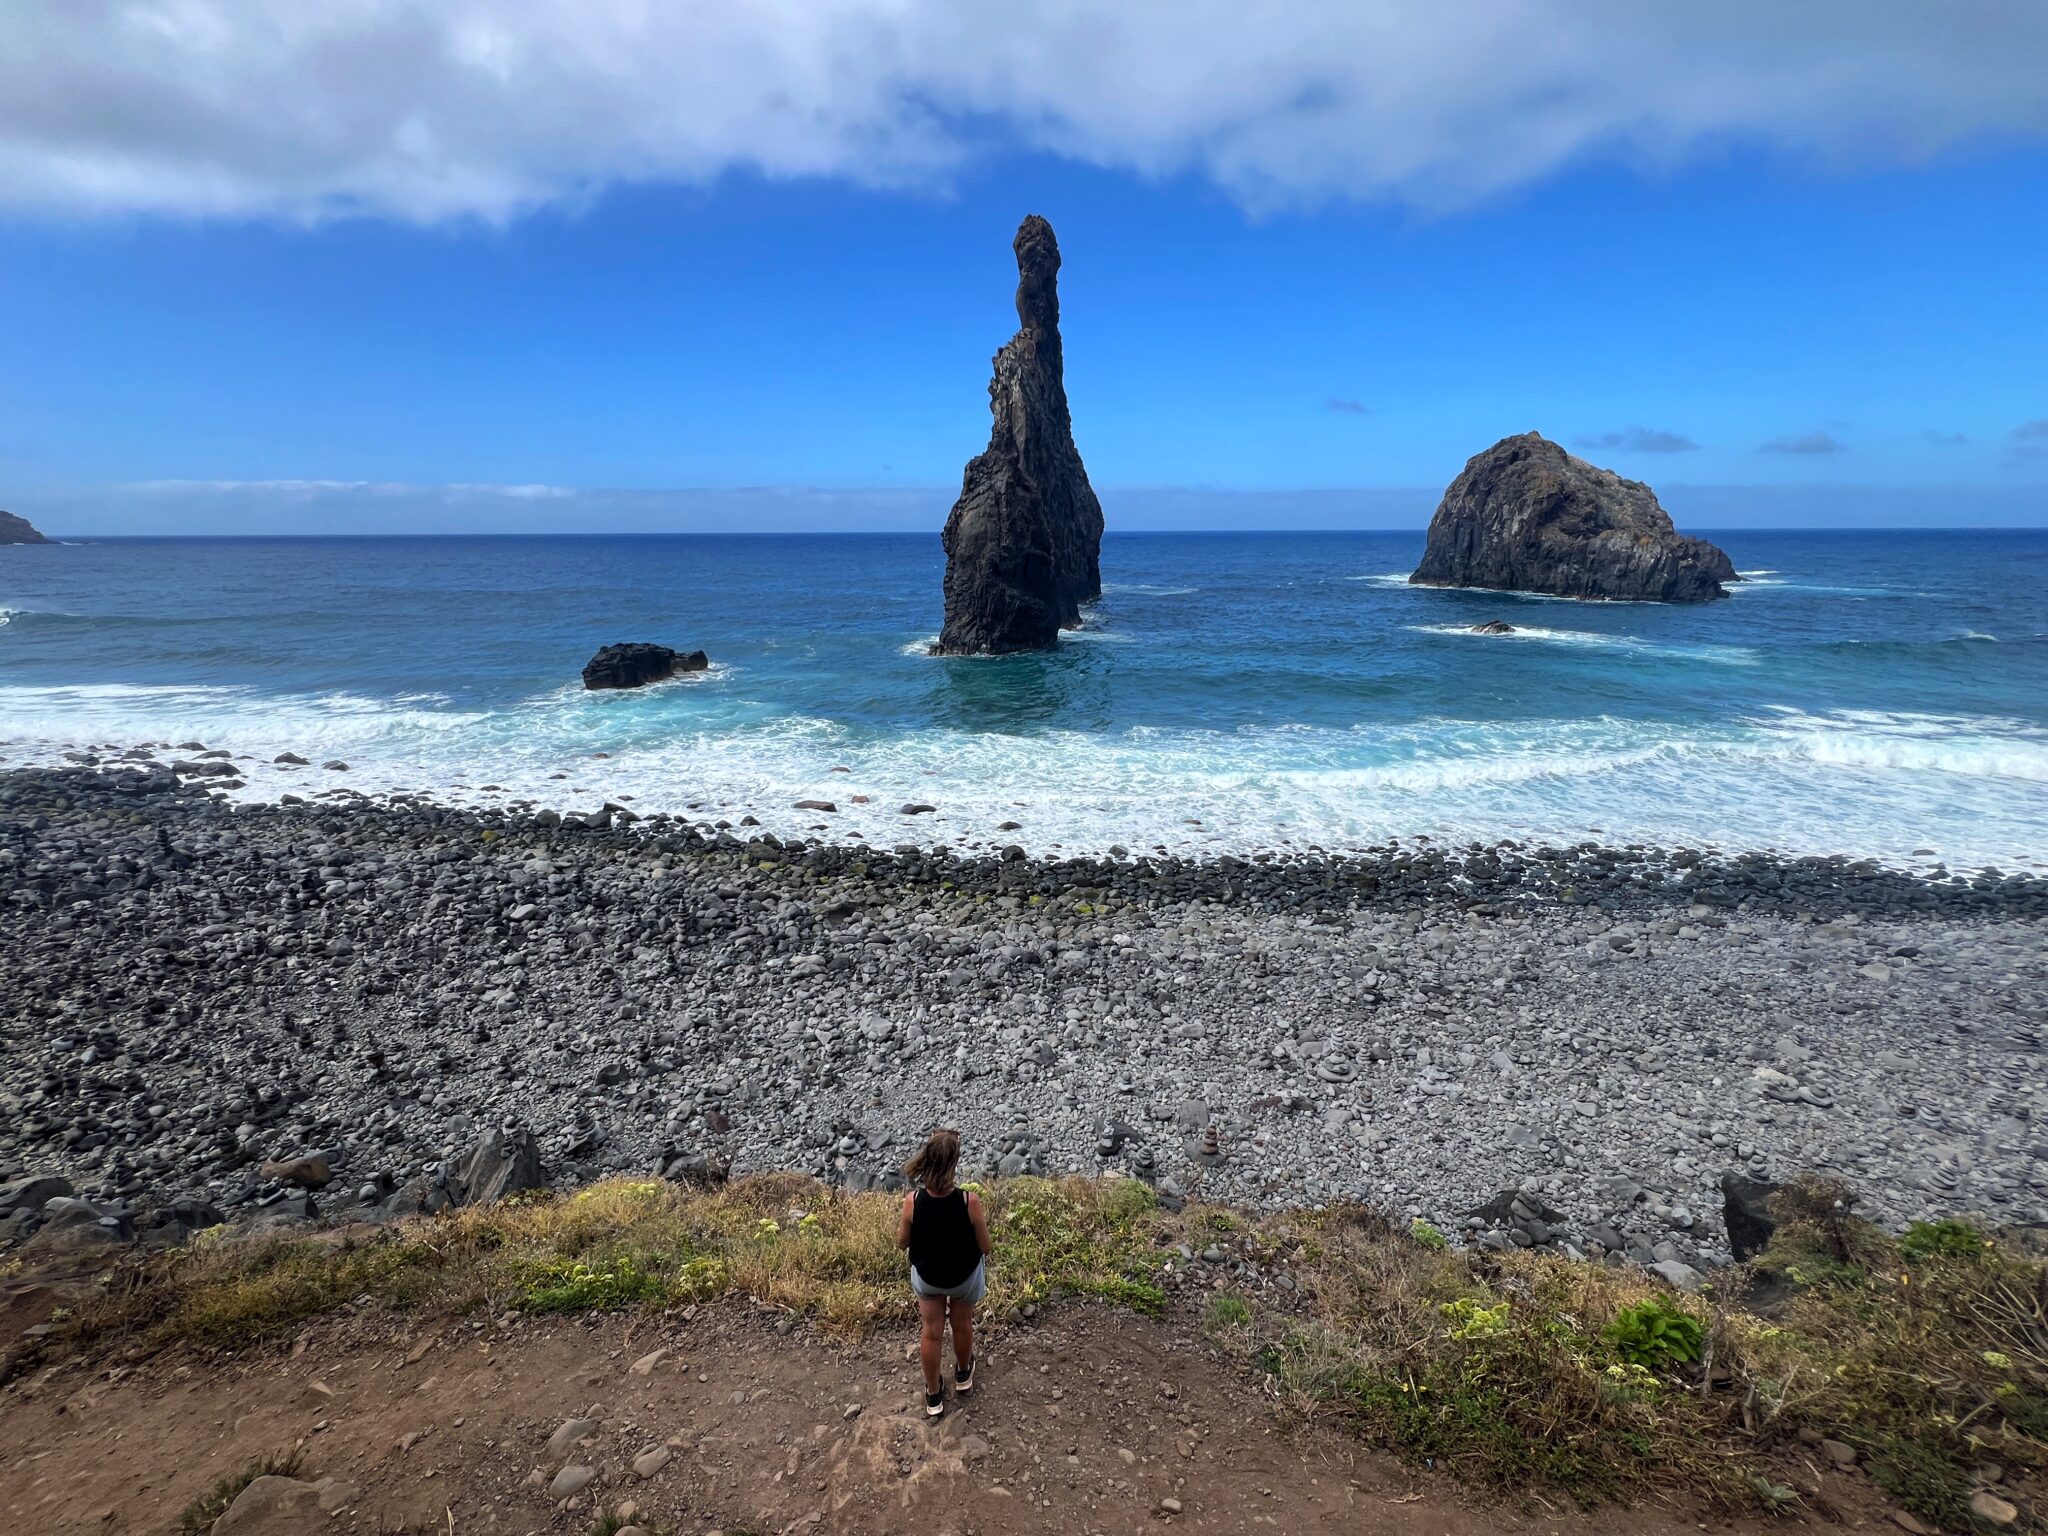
[0,1307,1894,1536]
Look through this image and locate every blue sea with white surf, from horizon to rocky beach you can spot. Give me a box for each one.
[0,530,2048,868]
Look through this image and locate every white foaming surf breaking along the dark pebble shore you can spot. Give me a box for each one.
[0,692,2048,868]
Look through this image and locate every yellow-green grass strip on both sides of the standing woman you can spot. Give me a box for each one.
[66,1176,1167,1350]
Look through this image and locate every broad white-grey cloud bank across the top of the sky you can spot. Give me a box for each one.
[0,0,2048,221]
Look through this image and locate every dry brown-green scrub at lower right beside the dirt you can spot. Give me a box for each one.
[1225,1186,2048,1530]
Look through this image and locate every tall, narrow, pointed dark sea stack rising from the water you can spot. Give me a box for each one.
[932,213,1102,655]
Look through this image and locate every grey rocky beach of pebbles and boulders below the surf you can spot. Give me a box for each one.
[0,756,2048,1268]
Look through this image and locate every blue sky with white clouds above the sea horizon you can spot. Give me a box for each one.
[0,0,2048,535]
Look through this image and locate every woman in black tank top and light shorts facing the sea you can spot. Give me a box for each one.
[897,1130,989,1419]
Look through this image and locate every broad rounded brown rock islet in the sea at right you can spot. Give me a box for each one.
[1409,432,1741,602]
